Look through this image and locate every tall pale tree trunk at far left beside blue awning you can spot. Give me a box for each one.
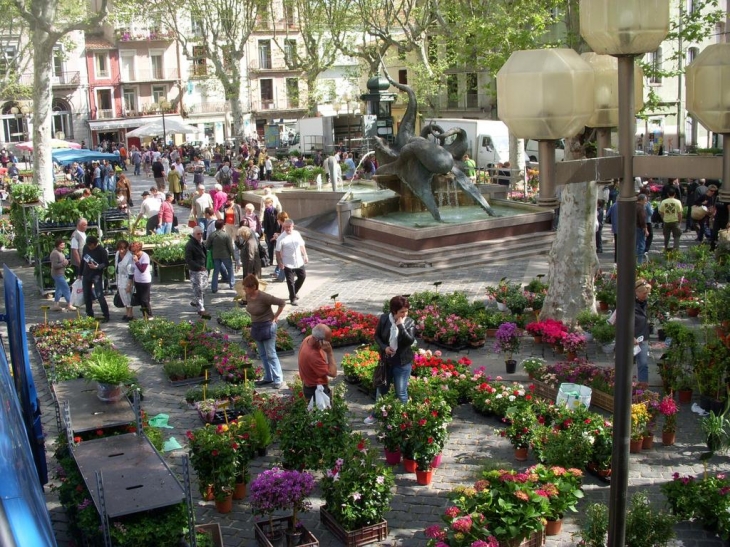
[32,34,54,203]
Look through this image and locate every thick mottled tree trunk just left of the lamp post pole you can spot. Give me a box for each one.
[540,182,598,323]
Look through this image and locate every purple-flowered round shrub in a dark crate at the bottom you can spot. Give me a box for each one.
[249,467,314,547]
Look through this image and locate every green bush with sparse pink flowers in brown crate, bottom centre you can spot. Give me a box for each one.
[320,433,395,545]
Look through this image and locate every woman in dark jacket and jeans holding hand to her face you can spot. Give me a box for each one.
[365,296,416,425]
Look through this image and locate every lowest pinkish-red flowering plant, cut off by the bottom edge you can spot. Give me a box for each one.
[424,507,499,547]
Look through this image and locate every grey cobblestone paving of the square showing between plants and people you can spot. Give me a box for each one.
[7,169,730,547]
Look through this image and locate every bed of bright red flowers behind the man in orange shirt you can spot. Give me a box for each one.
[287,302,378,347]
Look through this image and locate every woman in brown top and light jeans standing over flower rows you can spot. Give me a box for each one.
[243,274,286,389]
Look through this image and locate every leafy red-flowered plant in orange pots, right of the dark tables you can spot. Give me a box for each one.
[186,424,241,500]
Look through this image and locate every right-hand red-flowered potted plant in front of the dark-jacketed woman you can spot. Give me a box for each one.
[404,397,451,471]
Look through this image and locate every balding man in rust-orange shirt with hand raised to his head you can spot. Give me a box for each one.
[299,324,337,401]
